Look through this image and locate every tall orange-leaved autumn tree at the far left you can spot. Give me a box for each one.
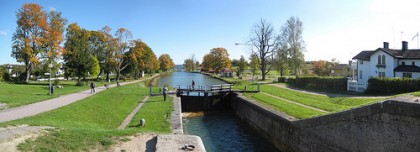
[11,3,67,82]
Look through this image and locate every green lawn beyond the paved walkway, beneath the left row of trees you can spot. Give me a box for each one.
[0,81,116,108]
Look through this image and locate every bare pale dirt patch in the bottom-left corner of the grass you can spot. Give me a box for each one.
[0,125,53,152]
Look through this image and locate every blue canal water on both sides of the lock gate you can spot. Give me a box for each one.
[159,72,277,152]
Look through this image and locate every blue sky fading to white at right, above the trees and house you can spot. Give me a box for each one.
[0,0,420,65]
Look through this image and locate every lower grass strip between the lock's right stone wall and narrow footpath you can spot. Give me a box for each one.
[246,93,326,119]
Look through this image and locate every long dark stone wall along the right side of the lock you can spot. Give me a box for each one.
[231,94,420,152]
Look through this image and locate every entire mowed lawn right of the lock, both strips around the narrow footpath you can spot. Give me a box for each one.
[247,84,385,119]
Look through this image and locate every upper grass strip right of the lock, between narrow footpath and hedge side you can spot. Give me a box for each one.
[261,85,384,112]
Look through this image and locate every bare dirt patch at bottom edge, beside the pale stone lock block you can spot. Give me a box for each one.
[109,133,157,152]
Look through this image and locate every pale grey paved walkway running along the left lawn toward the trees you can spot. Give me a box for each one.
[0,78,150,122]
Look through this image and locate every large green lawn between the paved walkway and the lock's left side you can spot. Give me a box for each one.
[0,79,172,151]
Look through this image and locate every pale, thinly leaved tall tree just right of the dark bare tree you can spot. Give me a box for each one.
[279,17,305,76]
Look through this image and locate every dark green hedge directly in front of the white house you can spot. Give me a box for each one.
[365,77,420,94]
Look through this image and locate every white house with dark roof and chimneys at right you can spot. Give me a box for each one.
[348,41,420,91]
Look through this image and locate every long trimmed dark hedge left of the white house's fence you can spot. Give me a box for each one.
[279,77,347,91]
